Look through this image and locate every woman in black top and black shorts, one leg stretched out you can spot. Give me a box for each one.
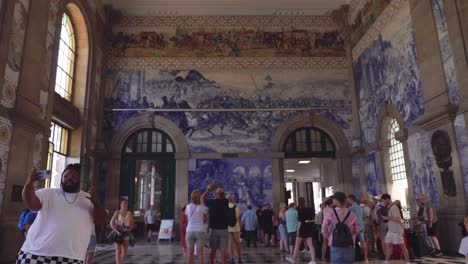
[286,197,315,264]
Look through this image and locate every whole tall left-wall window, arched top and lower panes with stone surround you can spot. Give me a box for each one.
[46,6,91,187]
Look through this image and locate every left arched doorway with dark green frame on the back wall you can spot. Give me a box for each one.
[119,128,176,219]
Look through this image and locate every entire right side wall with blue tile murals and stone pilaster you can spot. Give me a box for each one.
[350,0,466,251]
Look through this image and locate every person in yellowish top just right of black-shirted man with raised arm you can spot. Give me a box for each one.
[228,194,242,263]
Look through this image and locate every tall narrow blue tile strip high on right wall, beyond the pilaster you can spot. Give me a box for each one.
[432,0,460,104]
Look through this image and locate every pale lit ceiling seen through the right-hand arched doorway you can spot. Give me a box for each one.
[284,158,336,182]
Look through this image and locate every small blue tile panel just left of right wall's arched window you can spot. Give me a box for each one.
[364,152,382,196]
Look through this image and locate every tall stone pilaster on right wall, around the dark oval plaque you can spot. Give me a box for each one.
[410,0,466,252]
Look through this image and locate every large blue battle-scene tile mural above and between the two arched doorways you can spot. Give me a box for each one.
[105,70,352,153]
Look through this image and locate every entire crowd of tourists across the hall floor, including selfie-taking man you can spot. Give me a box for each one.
[12,164,468,264]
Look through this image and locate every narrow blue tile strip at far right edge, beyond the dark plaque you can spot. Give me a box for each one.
[455,115,468,200]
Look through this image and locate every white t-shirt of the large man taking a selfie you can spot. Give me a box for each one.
[21,188,94,261]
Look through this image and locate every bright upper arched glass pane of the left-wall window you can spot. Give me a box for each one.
[55,13,76,101]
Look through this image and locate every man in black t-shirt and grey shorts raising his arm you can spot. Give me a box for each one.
[201,184,229,264]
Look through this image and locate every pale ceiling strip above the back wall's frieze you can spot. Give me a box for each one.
[101,0,350,16]
